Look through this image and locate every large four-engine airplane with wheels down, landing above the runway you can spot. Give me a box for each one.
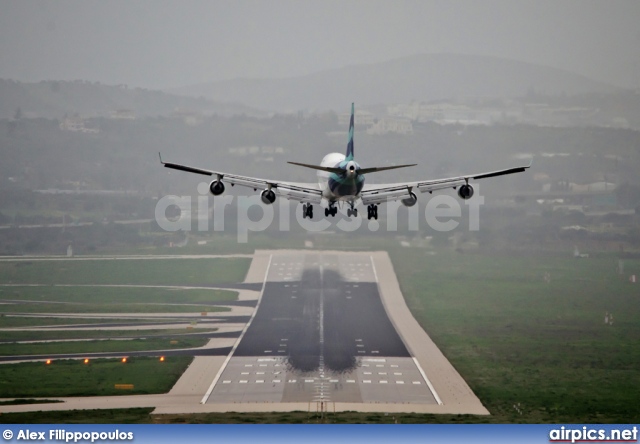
[160,103,531,219]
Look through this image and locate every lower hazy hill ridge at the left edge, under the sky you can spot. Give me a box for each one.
[0,79,256,119]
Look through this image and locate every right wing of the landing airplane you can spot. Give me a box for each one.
[360,163,531,205]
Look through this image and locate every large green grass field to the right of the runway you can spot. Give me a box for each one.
[391,249,640,423]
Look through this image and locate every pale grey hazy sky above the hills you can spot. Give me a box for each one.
[0,0,640,88]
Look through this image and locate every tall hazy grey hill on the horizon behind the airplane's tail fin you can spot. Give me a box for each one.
[171,54,616,111]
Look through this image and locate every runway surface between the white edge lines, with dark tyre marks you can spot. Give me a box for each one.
[206,253,436,404]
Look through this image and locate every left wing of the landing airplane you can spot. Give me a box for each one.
[160,157,322,204]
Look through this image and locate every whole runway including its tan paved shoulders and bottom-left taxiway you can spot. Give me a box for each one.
[3,250,489,415]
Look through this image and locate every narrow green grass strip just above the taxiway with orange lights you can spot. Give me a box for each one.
[0,333,208,356]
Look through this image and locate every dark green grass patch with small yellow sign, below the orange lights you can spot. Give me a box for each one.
[0,356,193,398]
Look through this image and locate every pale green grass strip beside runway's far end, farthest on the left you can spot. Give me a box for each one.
[0,258,251,286]
